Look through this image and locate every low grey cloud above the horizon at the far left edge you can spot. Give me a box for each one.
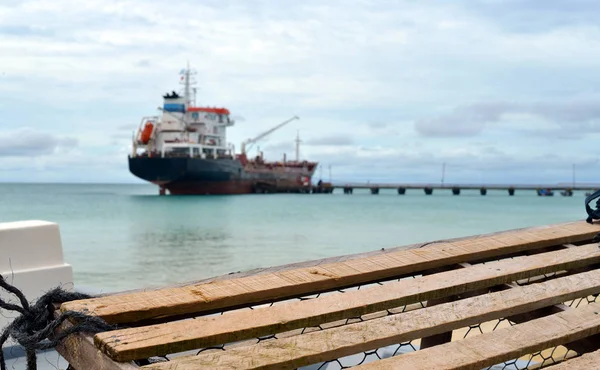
[0,128,78,157]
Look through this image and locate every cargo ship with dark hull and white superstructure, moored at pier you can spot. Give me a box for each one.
[128,65,318,195]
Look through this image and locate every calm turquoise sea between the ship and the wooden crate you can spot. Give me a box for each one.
[0,184,586,292]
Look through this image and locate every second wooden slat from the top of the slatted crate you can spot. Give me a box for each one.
[94,244,600,361]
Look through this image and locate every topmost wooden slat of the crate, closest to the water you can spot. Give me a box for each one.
[61,221,600,325]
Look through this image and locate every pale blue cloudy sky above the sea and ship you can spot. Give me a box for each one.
[0,0,600,184]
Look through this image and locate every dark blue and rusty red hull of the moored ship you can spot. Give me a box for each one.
[129,157,312,195]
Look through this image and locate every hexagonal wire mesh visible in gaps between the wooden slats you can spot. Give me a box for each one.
[135,260,598,370]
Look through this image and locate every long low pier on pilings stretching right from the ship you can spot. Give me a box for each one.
[312,182,600,196]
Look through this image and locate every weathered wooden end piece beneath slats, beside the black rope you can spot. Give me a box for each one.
[55,320,140,370]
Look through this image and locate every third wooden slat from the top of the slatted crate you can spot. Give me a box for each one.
[145,270,600,370]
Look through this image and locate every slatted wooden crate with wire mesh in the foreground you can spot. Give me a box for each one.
[57,221,600,370]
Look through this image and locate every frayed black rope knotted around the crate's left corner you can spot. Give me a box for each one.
[0,275,116,370]
